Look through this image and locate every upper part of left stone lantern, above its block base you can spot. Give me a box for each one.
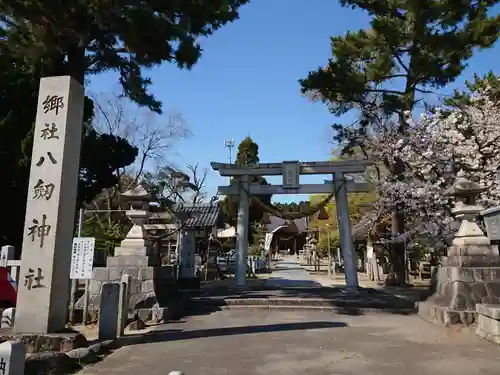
[115,185,152,256]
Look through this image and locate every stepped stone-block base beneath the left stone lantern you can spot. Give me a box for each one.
[75,255,178,322]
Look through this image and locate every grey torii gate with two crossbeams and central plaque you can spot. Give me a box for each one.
[210,160,374,289]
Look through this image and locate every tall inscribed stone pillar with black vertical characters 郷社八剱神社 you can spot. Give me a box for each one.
[14,76,84,334]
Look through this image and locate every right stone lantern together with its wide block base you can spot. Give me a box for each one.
[418,172,500,326]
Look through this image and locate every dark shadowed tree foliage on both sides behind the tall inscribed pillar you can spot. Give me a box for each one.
[0,55,137,249]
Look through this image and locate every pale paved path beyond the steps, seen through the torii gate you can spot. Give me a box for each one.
[265,257,321,288]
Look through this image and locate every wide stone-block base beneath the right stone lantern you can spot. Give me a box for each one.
[418,245,500,326]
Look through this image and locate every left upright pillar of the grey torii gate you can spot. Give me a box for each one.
[235,175,250,287]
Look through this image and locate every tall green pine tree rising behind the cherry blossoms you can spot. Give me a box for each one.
[300,0,500,283]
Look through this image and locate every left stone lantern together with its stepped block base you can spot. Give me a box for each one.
[76,185,176,321]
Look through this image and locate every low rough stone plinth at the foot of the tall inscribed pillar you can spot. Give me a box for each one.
[0,330,89,354]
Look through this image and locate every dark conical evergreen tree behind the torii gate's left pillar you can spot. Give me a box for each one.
[222,137,272,244]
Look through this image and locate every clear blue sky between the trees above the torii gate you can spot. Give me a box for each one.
[89,0,500,201]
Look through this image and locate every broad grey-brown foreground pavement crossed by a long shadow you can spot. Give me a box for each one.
[80,310,500,375]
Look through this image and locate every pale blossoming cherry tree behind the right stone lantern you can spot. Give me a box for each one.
[360,81,500,258]
